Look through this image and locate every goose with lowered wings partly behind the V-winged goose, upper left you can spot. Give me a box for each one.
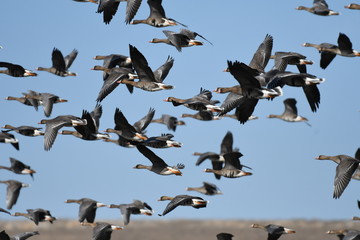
[91,65,137,102]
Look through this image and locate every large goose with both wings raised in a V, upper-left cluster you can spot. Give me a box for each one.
[118,45,174,92]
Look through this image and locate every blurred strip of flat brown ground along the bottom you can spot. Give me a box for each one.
[0,220,360,240]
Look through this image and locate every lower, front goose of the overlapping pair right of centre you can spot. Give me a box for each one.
[204,152,252,178]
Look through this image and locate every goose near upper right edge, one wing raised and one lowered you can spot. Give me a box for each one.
[303,33,360,69]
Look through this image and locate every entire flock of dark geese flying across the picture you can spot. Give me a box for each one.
[0,0,360,240]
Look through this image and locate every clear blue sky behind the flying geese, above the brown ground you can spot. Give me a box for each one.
[0,0,360,223]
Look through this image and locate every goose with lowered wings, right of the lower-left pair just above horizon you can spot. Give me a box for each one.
[108,200,154,225]
